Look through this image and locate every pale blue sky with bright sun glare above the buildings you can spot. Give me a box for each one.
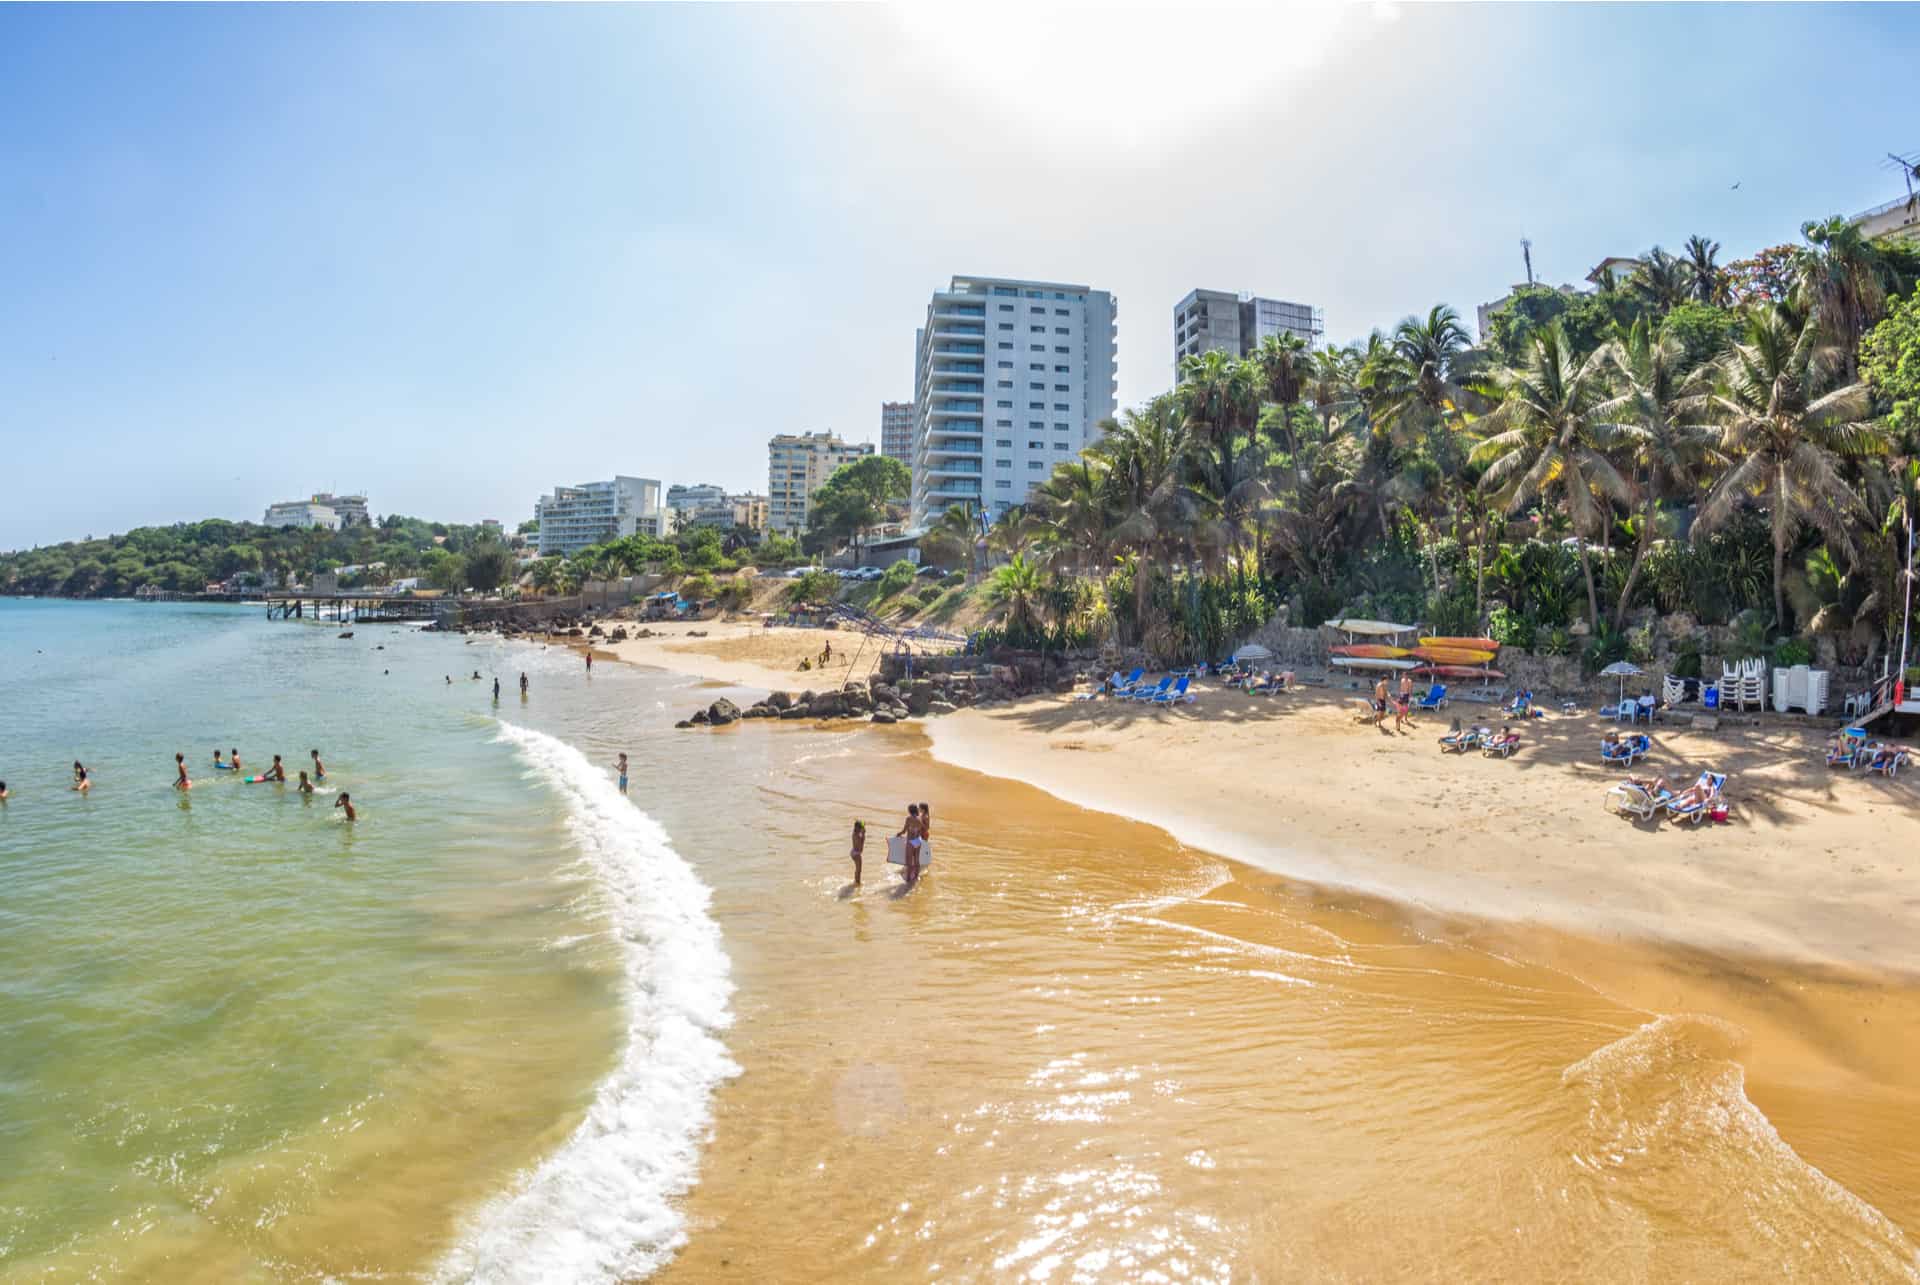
[0,4,1920,549]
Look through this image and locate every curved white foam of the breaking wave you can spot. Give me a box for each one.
[436,724,739,1281]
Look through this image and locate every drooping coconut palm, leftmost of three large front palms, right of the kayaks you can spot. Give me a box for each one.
[1473,321,1634,630]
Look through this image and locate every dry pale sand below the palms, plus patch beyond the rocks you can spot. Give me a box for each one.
[603,622,1920,980]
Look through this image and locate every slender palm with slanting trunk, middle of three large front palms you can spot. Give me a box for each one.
[1596,318,1724,628]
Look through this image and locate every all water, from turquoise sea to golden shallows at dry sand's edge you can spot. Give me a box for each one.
[0,601,1920,1281]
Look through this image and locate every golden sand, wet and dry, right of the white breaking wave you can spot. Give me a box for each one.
[591,626,1920,1281]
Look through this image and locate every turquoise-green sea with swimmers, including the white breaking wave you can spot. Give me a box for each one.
[0,599,728,1279]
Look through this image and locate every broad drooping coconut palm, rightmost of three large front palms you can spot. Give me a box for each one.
[1693,307,1885,628]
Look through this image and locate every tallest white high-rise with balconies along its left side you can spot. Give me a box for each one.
[908,277,1119,526]
